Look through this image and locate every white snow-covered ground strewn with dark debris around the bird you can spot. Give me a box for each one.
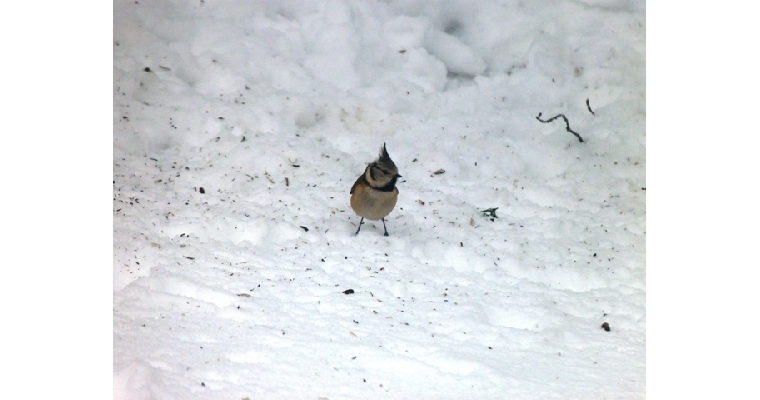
[113,0,646,399]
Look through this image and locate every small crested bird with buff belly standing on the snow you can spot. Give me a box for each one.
[350,143,401,236]
